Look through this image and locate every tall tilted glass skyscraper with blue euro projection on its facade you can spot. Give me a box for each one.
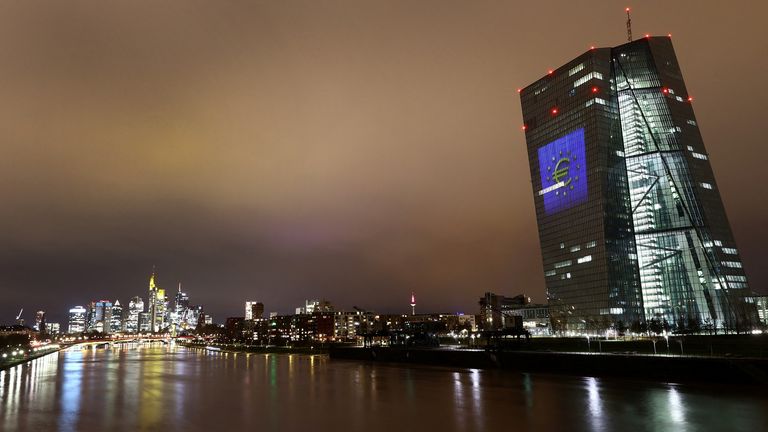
[520,37,757,333]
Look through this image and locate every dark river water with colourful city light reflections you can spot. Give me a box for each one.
[0,345,768,432]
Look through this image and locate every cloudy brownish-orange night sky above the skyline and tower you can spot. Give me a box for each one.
[0,0,768,324]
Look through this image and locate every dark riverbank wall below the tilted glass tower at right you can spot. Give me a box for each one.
[329,347,768,384]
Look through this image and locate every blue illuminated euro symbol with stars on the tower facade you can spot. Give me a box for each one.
[539,128,587,214]
